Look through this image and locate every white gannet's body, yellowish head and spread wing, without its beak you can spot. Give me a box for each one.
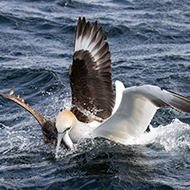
[56,81,190,151]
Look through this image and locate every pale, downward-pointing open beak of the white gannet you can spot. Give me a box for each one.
[56,130,74,155]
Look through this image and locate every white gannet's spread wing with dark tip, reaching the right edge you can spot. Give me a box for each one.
[93,81,190,144]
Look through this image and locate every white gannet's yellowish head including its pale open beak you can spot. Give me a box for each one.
[56,110,76,153]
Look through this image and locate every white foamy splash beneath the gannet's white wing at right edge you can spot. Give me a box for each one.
[131,119,190,153]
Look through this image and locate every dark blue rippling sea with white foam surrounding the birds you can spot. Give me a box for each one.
[0,0,190,190]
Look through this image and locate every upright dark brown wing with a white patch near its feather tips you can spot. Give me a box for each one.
[69,17,114,122]
